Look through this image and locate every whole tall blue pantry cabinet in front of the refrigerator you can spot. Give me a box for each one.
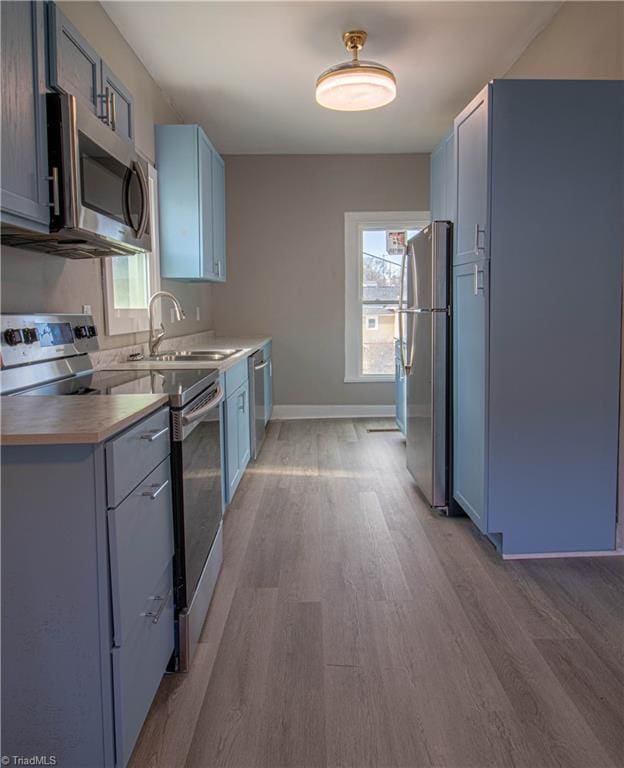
[453,80,624,555]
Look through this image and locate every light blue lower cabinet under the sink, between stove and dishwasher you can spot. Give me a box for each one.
[224,372,251,504]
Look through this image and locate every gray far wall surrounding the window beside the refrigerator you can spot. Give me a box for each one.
[213,155,429,405]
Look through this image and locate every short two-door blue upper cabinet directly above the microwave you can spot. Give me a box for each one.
[47,3,134,143]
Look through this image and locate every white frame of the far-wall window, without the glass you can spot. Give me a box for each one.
[344,211,431,384]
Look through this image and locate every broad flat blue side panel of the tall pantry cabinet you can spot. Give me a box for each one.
[490,80,624,553]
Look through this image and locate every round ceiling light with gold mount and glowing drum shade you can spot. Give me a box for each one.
[316,30,396,112]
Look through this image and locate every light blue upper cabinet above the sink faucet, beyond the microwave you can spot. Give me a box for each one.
[156,125,226,282]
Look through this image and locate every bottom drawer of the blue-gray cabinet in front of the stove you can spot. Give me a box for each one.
[112,563,174,767]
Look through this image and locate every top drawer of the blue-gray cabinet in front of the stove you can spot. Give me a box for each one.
[106,408,170,507]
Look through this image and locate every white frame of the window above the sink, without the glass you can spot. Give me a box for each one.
[102,163,162,336]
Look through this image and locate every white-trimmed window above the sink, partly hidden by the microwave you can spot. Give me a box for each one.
[102,165,160,336]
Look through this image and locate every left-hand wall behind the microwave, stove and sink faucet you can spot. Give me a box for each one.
[0,2,212,348]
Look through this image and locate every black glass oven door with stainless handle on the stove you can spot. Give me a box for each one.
[171,382,224,612]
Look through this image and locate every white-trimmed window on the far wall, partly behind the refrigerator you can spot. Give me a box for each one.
[345,211,431,382]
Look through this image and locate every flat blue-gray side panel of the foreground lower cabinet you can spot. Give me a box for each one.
[2,446,114,766]
